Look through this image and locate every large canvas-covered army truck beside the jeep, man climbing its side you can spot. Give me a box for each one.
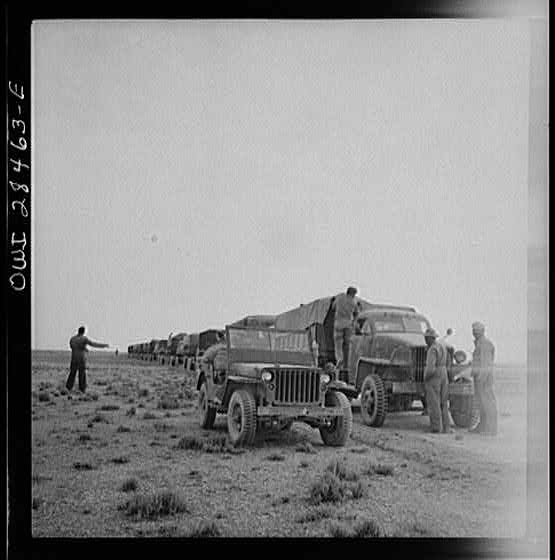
[276,297,478,428]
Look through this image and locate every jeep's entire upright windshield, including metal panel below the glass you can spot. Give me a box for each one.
[228,327,313,365]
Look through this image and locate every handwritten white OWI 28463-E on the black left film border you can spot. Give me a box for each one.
[8,81,30,292]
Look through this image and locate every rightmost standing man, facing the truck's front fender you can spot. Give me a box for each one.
[470,322,497,436]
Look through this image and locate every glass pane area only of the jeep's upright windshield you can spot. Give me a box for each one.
[229,329,310,352]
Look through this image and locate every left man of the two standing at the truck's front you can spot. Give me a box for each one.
[424,328,452,433]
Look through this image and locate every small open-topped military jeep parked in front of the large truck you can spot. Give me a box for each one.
[196,326,354,446]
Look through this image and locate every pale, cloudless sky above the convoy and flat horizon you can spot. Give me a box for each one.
[32,18,530,362]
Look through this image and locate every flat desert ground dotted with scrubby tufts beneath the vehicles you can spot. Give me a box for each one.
[29,351,526,538]
